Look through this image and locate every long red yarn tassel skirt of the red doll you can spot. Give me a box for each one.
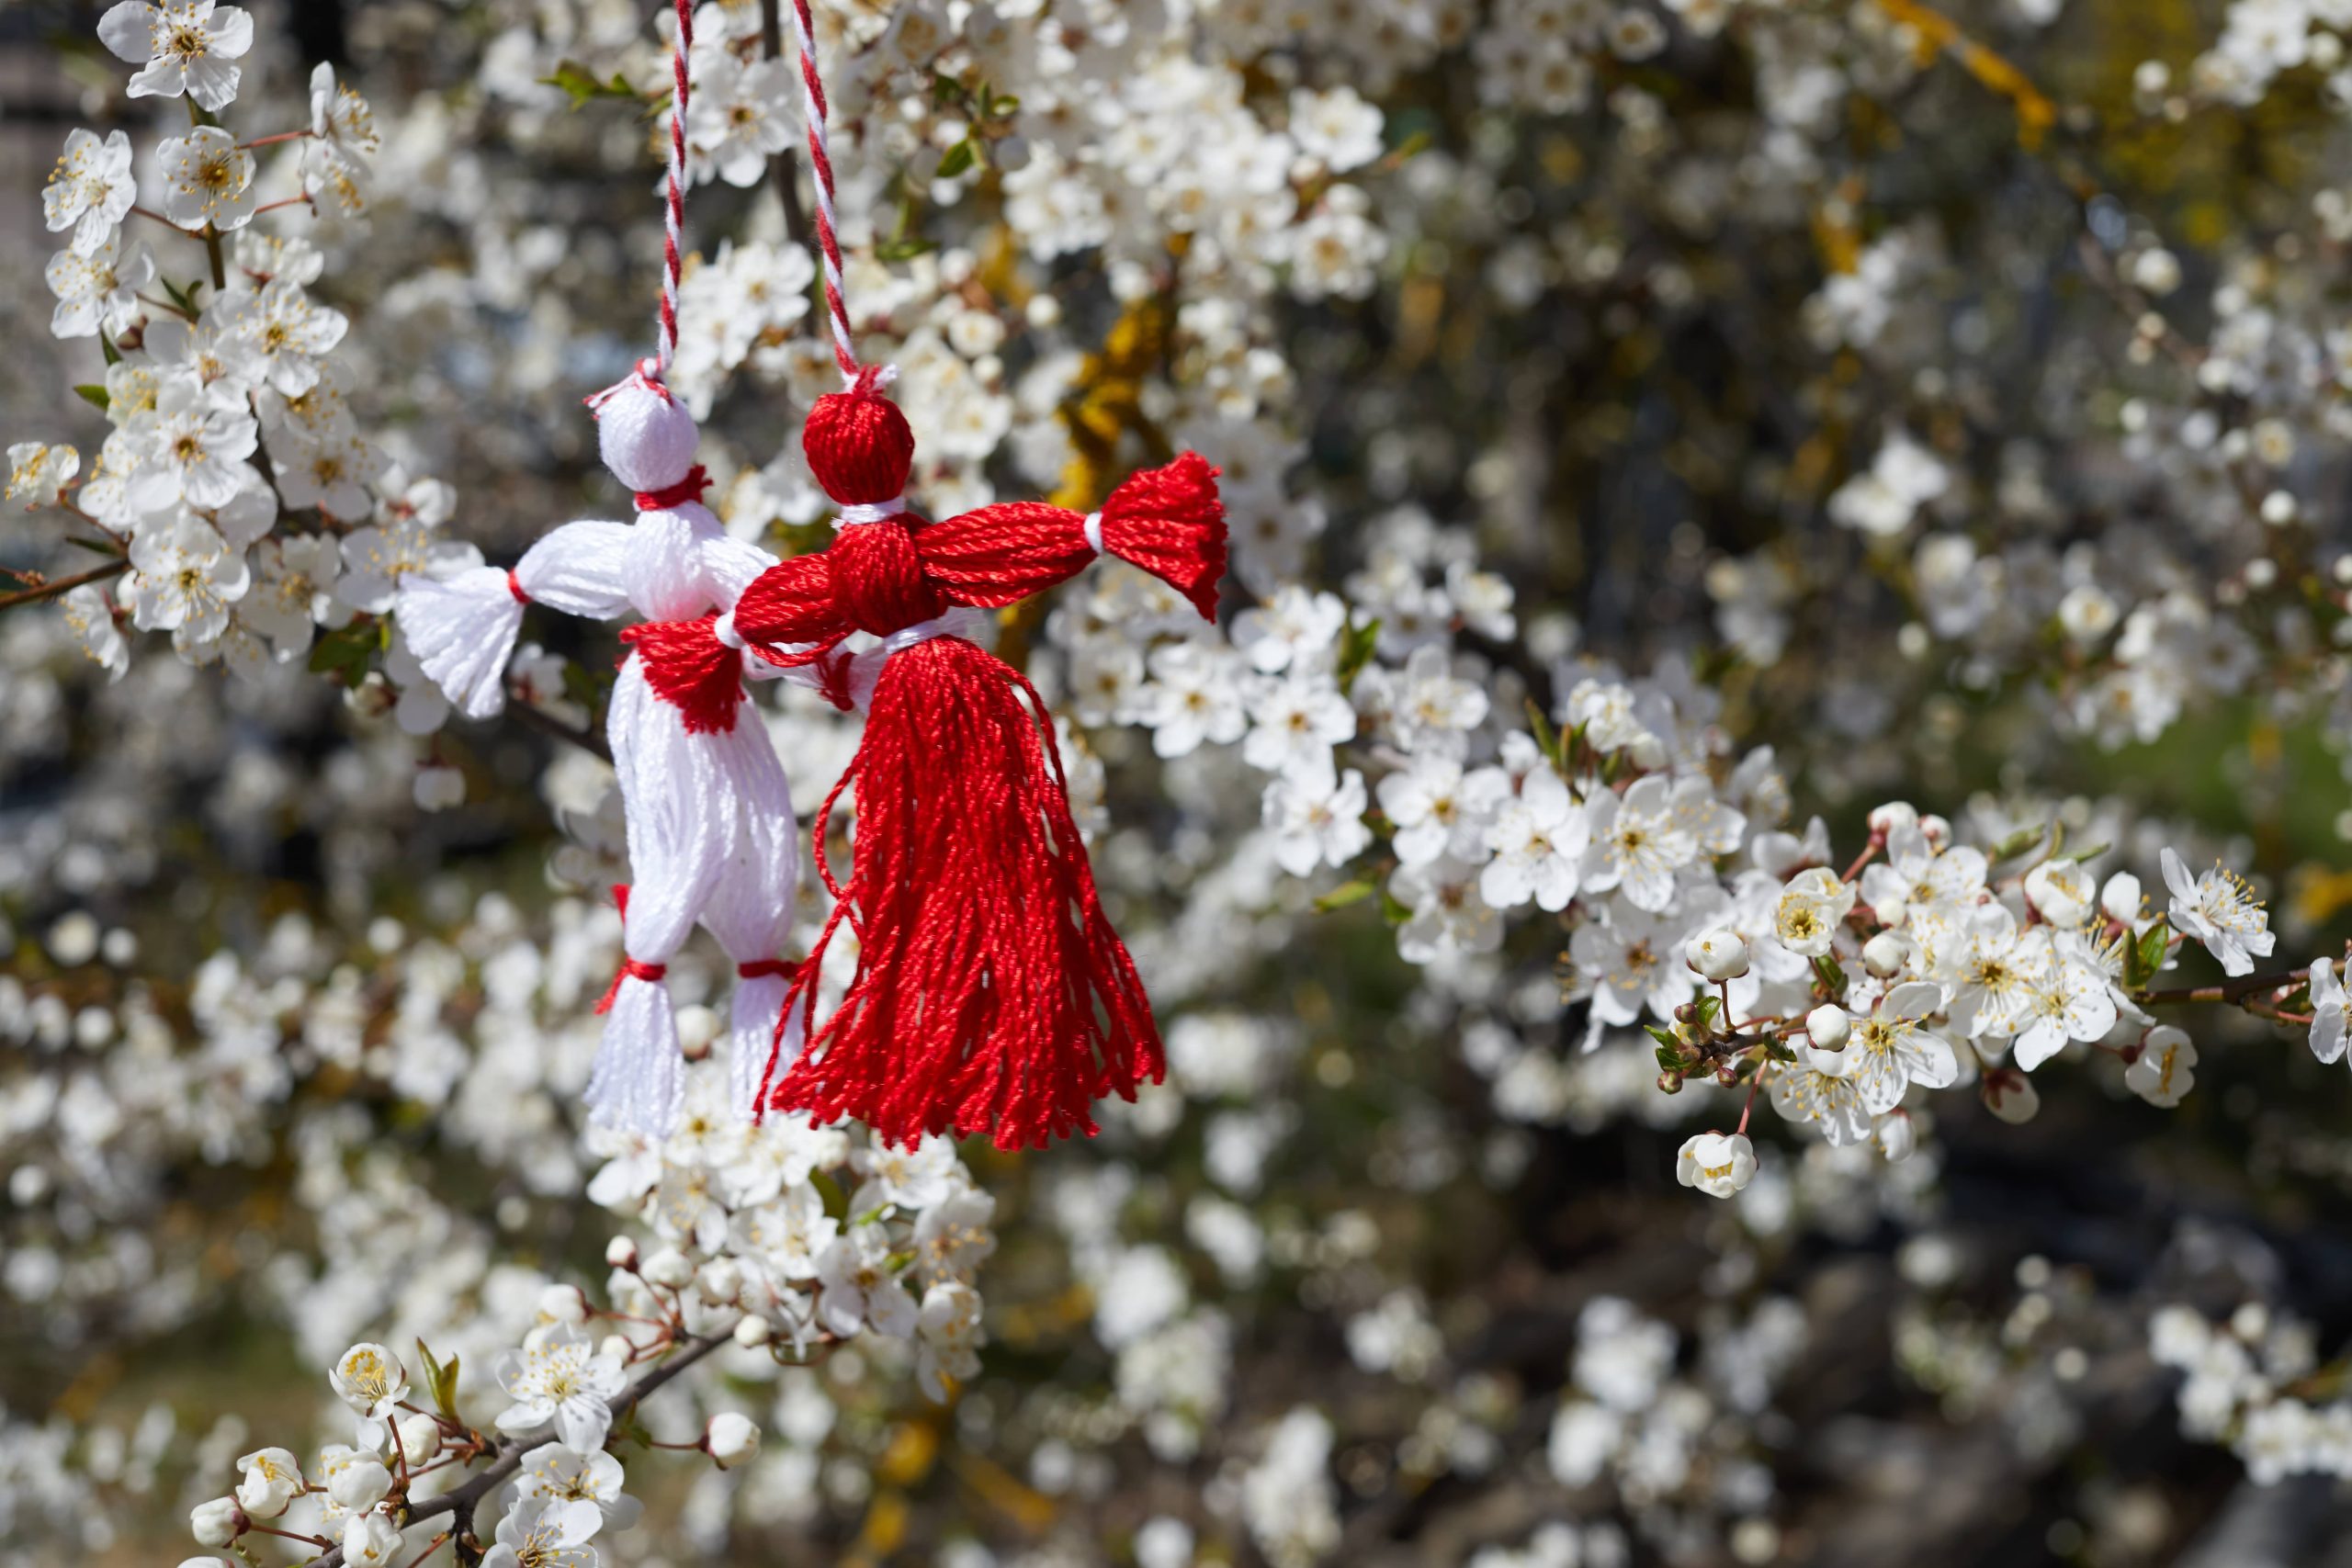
[767,637,1164,1149]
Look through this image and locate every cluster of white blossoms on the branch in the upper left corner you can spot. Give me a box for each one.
[7,0,402,677]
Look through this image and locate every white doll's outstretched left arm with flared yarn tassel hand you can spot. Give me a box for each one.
[393,522,628,719]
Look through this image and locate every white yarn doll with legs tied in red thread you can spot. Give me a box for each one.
[395,374,818,1135]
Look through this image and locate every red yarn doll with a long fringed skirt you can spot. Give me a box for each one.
[734,371,1226,1149]
